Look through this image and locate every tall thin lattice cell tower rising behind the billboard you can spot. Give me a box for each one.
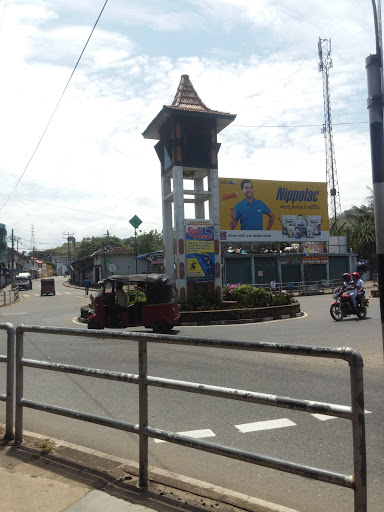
[318,37,341,229]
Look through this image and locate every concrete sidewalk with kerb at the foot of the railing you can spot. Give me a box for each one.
[0,425,296,512]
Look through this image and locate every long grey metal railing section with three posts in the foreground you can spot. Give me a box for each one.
[11,325,367,512]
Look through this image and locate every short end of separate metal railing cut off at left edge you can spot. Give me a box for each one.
[0,323,15,441]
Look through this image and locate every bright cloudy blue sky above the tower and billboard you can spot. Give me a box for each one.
[0,0,375,249]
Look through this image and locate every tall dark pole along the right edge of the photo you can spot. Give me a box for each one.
[365,0,384,353]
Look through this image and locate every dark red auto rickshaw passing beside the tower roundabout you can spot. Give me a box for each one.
[88,274,180,333]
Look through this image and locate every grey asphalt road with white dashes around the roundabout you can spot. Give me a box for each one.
[0,278,384,512]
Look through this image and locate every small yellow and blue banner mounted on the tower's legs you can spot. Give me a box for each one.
[185,219,215,281]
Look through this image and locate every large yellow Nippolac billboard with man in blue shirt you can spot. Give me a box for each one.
[219,178,329,243]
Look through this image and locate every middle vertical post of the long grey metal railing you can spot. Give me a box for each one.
[139,340,148,491]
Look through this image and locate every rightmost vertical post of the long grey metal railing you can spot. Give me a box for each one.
[349,354,368,512]
